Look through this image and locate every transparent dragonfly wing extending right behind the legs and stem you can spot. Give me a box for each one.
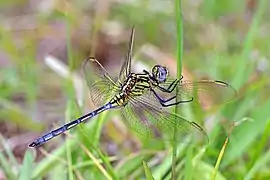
[158,80,237,107]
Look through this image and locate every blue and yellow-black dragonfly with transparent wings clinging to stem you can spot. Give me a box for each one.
[29,26,236,147]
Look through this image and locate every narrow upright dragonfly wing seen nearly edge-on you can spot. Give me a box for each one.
[118,26,135,82]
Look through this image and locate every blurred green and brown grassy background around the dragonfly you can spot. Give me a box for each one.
[0,0,270,180]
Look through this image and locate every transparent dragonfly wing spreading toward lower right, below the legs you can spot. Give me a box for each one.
[121,92,208,142]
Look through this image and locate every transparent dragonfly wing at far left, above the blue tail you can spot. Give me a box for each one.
[83,57,120,106]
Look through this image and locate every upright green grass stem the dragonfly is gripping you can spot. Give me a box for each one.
[171,0,184,180]
